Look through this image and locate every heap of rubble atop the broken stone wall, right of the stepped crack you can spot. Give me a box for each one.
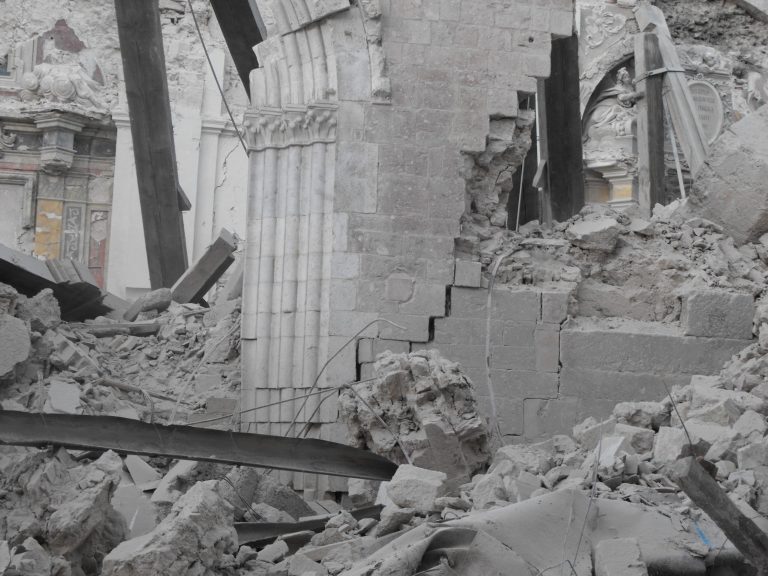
[460,202,768,322]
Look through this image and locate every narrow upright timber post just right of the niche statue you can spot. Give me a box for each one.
[635,32,666,214]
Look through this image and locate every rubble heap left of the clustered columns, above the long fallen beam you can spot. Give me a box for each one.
[0,285,240,424]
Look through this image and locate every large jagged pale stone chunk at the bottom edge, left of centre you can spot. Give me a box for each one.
[102,480,237,576]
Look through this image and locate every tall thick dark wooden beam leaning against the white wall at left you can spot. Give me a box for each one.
[115,0,187,289]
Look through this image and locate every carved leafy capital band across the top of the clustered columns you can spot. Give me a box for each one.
[243,102,337,151]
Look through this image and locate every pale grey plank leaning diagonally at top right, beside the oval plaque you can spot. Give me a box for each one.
[635,4,709,176]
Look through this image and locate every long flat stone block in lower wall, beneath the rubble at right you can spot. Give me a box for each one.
[560,319,746,375]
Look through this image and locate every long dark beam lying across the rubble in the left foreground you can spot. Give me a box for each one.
[0,410,397,480]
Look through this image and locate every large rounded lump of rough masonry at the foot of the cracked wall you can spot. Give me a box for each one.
[339,350,490,479]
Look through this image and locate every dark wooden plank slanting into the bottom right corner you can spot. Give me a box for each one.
[671,457,768,576]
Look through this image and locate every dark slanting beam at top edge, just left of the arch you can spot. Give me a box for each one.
[211,0,262,97]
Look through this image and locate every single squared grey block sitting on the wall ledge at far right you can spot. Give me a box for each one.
[680,290,755,340]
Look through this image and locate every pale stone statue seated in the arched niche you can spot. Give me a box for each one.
[585,68,641,152]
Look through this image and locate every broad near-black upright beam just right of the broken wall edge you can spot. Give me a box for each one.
[544,34,584,222]
